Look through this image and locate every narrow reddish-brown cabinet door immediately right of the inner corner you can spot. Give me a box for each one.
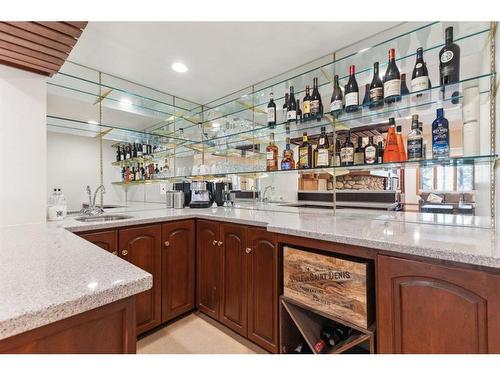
[196,220,221,319]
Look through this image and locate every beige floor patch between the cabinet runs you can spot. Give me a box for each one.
[137,312,266,354]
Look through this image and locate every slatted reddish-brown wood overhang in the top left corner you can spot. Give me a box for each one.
[0,21,87,75]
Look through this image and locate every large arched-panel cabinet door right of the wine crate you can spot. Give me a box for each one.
[377,256,500,354]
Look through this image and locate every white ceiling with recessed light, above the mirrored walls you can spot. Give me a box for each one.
[69,22,397,104]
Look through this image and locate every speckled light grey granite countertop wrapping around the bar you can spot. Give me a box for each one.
[0,204,500,339]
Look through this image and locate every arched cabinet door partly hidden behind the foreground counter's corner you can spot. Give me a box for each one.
[119,224,161,334]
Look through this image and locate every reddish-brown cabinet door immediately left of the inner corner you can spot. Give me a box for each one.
[161,220,195,322]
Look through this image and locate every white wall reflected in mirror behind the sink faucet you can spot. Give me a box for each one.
[47,132,123,211]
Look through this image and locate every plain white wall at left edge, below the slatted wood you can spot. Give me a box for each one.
[0,65,47,225]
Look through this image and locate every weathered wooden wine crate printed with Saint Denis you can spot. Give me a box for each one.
[283,246,374,329]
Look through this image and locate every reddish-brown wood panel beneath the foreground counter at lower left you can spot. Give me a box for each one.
[0,296,137,354]
